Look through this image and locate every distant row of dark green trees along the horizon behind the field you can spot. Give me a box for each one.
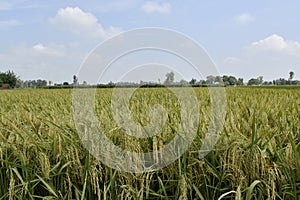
[0,70,300,89]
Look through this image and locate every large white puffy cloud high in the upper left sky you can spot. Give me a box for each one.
[49,7,121,39]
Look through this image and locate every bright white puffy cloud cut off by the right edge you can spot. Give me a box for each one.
[251,34,300,56]
